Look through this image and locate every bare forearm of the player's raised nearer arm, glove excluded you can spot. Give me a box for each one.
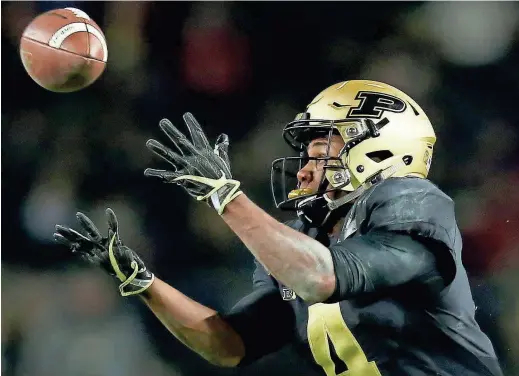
[223,194,335,302]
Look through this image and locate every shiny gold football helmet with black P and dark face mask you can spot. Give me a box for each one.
[271,80,436,225]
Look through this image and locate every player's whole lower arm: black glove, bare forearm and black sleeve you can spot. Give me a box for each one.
[54,209,289,367]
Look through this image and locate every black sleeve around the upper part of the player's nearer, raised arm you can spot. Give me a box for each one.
[326,232,445,303]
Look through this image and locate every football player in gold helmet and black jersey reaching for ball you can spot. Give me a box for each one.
[55,80,501,376]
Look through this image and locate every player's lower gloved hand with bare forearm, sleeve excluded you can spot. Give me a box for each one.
[54,209,244,366]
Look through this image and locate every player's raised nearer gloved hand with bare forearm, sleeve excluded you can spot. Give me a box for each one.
[144,113,335,302]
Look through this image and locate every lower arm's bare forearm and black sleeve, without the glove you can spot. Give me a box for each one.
[142,266,294,367]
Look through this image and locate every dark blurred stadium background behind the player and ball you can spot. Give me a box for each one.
[1,1,519,376]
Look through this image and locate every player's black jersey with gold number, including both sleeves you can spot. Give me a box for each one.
[226,178,501,376]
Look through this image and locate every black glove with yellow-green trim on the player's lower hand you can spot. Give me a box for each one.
[54,208,155,296]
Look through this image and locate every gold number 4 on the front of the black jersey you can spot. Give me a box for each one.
[307,303,381,376]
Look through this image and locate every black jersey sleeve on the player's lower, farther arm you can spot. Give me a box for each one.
[223,261,295,366]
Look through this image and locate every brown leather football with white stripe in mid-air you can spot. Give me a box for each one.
[20,8,108,93]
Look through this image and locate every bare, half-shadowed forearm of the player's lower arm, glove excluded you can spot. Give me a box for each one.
[142,278,244,367]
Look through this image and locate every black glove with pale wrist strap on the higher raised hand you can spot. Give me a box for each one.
[144,112,242,215]
